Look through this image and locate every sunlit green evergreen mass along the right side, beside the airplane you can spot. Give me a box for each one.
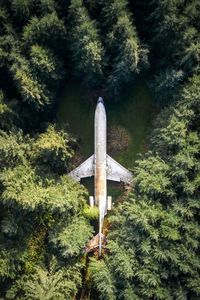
[92,76,200,299]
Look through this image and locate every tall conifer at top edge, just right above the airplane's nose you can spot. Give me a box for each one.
[102,0,148,96]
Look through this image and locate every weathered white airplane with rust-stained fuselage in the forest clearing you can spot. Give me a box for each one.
[68,97,132,256]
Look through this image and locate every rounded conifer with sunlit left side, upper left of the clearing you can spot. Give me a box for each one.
[10,45,64,110]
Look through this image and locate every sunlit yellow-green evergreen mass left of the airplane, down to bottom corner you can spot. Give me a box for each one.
[0,126,92,299]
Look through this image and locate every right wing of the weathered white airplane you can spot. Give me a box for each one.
[107,154,132,183]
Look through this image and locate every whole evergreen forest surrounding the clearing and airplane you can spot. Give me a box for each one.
[0,0,200,300]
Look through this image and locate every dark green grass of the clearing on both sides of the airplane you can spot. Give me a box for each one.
[57,80,157,198]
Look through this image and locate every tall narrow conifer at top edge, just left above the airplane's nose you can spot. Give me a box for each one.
[68,0,103,85]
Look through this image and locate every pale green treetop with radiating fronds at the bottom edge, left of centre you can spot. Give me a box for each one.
[6,257,81,300]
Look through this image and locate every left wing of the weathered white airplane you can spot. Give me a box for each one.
[68,154,94,181]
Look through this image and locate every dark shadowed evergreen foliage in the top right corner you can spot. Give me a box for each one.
[148,0,200,104]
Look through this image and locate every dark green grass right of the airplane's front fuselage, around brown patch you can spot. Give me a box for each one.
[107,80,156,168]
